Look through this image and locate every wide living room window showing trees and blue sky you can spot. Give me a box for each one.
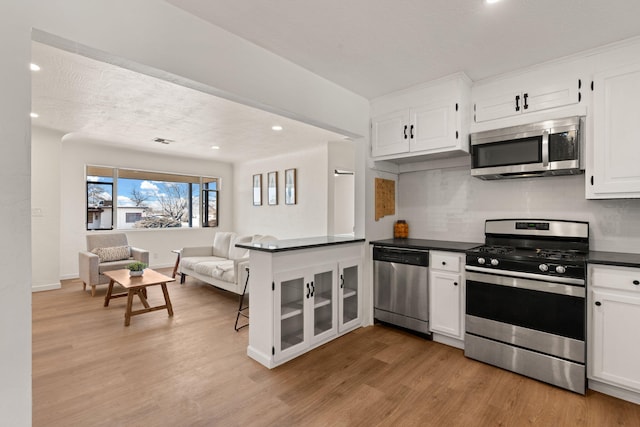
[86,166,219,230]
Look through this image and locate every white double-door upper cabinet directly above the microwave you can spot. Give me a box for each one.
[472,61,585,123]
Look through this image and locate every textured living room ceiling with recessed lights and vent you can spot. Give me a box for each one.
[32,42,343,162]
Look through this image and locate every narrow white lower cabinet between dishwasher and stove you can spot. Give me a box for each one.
[429,251,465,347]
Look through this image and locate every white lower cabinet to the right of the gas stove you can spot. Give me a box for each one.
[587,265,640,402]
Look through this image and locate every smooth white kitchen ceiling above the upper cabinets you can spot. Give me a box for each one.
[166,0,640,99]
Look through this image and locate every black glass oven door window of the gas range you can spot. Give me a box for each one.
[467,280,585,341]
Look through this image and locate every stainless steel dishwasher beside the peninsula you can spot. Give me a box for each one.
[373,246,429,334]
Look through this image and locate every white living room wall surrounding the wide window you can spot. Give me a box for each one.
[57,135,234,278]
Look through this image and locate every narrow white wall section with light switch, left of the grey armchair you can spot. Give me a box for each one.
[31,127,62,291]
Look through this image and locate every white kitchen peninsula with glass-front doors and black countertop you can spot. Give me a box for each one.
[236,236,364,368]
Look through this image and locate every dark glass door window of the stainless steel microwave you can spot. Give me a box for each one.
[471,136,542,168]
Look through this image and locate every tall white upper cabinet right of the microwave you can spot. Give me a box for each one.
[586,63,640,199]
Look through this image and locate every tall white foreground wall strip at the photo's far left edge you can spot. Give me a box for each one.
[0,2,31,426]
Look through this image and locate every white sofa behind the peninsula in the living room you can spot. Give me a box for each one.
[178,231,276,295]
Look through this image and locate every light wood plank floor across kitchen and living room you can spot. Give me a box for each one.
[33,270,640,427]
